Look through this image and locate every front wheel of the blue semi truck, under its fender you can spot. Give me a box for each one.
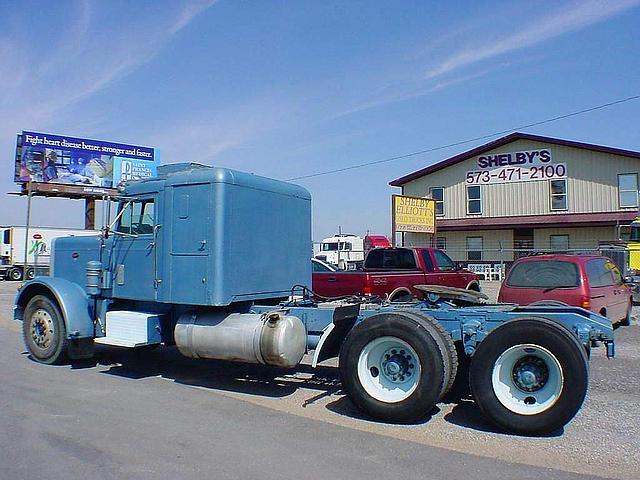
[22,295,67,364]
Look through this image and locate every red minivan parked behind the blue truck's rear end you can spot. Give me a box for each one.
[498,254,632,325]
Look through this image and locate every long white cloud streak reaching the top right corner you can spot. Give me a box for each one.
[425,0,640,79]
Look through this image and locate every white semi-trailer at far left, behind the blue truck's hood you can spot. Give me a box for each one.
[0,226,100,280]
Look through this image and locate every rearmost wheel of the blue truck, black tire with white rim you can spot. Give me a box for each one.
[470,317,589,435]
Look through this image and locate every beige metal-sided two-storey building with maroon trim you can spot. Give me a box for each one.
[390,133,640,261]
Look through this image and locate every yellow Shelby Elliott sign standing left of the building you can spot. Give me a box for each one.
[391,195,436,233]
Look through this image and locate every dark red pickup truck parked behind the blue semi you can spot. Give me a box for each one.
[312,248,480,301]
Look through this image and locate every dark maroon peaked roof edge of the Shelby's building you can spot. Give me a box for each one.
[389,132,640,187]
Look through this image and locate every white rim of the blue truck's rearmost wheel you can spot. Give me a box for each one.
[491,344,564,415]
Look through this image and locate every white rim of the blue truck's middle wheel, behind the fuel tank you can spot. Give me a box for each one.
[358,336,422,403]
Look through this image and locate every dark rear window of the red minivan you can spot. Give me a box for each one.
[507,260,580,288]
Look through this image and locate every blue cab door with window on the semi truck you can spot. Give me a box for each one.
[111,196,161,301]
